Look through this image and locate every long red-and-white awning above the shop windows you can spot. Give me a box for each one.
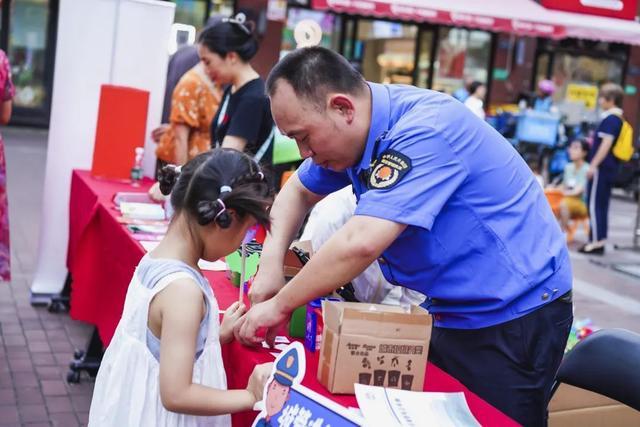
[311,0,640,45]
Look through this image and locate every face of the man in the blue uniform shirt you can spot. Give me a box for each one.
[271,80,362,171]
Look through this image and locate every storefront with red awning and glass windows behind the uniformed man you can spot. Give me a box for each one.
[268,0,640,129]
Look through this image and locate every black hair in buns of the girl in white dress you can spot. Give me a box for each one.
[158,148,272,228]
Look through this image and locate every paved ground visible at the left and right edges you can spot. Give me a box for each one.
[0,128,640,427]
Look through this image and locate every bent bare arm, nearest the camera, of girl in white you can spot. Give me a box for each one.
[155,279,268,415]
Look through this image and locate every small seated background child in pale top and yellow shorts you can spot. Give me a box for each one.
[558,141,590,232]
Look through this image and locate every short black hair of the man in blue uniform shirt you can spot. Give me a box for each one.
[266,46,367,108]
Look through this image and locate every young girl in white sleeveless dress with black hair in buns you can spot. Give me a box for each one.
[89,148,271,427]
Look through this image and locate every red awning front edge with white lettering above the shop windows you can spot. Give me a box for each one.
[311,0,565,38]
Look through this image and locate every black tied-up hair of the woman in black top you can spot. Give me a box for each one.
[198,20,258,62]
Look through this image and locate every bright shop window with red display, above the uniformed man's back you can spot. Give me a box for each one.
[433,28,491,94]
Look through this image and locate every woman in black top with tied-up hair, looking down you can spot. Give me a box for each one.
[198,14,273,165]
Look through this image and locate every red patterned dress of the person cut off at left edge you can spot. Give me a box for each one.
[0,50,16,282]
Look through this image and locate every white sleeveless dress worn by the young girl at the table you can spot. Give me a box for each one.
[89,271,231,427]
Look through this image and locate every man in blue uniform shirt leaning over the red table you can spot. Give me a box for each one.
[236,47,572,425]
